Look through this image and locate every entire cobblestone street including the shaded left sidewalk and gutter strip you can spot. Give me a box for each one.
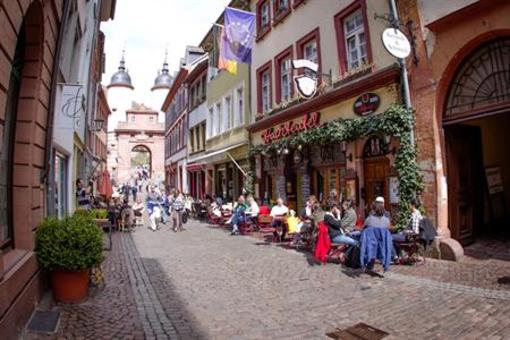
[34,221,510,339]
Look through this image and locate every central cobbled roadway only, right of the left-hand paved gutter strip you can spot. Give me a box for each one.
[126,222,510,339]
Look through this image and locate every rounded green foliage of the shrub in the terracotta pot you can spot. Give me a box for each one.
[36,213,103,271]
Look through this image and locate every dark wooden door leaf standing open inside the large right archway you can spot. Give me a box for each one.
[445,125,484,245]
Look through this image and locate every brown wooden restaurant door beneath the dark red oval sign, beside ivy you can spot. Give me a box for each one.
[364,157,390,213]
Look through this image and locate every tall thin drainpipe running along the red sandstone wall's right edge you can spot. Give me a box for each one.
[41,0,71,215]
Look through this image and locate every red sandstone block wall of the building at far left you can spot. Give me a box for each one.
[0,0,62,339]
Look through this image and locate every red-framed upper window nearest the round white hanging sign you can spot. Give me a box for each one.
[335,0,372,73]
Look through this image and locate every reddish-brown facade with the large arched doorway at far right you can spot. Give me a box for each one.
[399,0,510,259]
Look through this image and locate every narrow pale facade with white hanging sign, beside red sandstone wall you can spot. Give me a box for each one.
[47,1,112,217]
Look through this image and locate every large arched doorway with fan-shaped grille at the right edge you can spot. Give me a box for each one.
[443,37,510,245]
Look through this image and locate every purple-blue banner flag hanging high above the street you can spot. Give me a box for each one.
[220,7,255,64]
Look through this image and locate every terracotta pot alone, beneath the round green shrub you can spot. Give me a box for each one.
[50,269,89,303]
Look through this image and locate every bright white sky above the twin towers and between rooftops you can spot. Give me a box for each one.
[101,0,230,110]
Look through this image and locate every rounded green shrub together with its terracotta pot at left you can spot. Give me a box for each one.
[36,214,103,303]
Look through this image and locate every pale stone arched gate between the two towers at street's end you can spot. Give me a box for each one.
[114,104,165,185]
